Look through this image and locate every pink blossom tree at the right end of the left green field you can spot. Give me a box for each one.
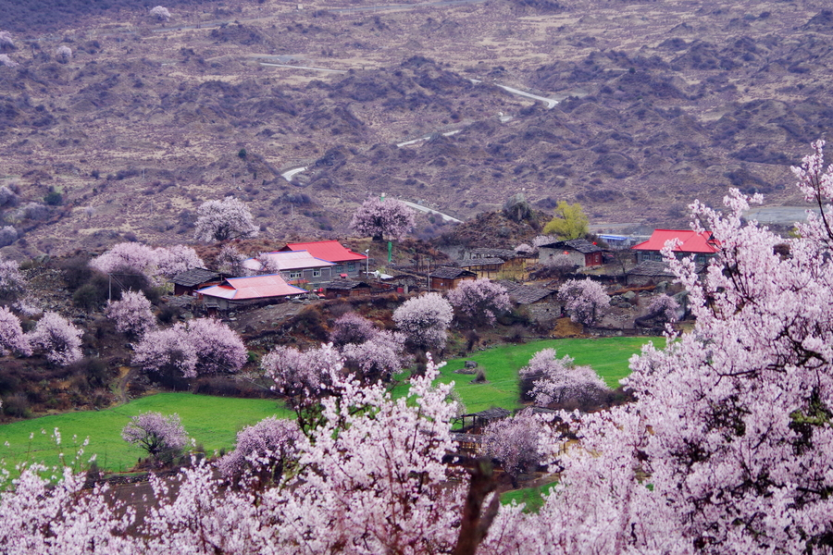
[217,416,301,483]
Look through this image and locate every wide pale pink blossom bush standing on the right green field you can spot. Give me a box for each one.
[518,349,610,407]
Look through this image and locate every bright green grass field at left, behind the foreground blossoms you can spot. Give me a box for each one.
[0,393,290,471]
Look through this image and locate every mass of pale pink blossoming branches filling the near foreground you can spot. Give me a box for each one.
[8,143,833,555]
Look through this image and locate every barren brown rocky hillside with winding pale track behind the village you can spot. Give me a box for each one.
[0,0,833,259]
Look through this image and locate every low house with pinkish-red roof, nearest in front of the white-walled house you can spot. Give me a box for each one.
[197,274,307,310]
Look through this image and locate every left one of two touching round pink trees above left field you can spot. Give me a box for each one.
[132,324,197,378]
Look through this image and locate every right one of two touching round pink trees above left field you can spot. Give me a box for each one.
[187,318,248,374]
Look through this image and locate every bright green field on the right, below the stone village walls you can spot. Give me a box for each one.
[410,337,664,412]
